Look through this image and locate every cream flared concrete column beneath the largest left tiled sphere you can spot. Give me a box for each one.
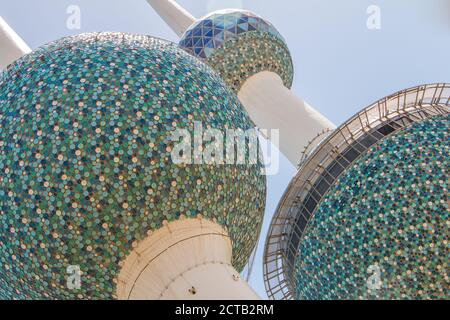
[117,219,259,300]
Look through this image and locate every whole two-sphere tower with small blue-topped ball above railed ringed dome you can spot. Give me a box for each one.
[148,0,450,299]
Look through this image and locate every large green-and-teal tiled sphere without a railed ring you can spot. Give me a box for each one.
[0,33,265,299]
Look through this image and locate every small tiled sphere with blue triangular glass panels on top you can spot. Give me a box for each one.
[180,10,294,92]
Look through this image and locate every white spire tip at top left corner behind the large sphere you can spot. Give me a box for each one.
[0,17,31,69]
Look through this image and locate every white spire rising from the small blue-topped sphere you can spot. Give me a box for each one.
[147,0,196,37]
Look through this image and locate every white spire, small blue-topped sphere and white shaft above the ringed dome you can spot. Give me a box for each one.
[147,0,335,166]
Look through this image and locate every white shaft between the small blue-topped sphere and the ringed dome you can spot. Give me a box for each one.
[238,71,336,165]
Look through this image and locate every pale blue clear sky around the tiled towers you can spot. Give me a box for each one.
[0,0,450,297]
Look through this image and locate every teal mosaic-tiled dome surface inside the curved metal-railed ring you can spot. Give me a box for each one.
[296,116,450,299]
